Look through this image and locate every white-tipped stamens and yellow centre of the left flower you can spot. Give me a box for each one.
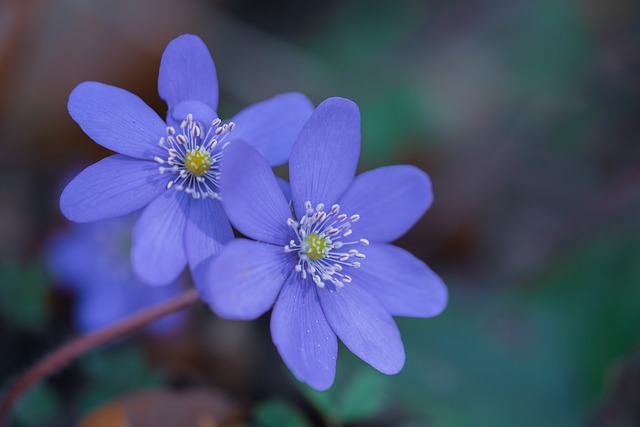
[154,114,235,199]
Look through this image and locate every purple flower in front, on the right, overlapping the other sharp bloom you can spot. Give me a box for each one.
[199,98,447,390]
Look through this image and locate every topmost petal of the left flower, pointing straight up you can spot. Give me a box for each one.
[158,34,218,112]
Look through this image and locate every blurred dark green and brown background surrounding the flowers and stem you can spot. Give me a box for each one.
[0,0,640,427]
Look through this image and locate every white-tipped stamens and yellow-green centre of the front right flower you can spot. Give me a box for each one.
[284,202,369,288]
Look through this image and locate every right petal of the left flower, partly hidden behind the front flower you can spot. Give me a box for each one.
[232,93,313,166]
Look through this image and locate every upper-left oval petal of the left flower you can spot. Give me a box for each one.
[67,82,166,160]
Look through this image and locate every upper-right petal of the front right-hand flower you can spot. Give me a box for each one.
[339,165,433,242]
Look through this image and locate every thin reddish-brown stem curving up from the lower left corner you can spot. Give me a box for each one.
[0,289,200,426]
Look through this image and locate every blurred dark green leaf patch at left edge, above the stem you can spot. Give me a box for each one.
[0,260,50,332]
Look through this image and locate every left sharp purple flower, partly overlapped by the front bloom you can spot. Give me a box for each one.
[60,35,313,285]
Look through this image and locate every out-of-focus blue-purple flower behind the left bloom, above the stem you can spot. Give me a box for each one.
[46,214,186,333]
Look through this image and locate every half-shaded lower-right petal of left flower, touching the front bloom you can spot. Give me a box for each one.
[184,199,233,269]
